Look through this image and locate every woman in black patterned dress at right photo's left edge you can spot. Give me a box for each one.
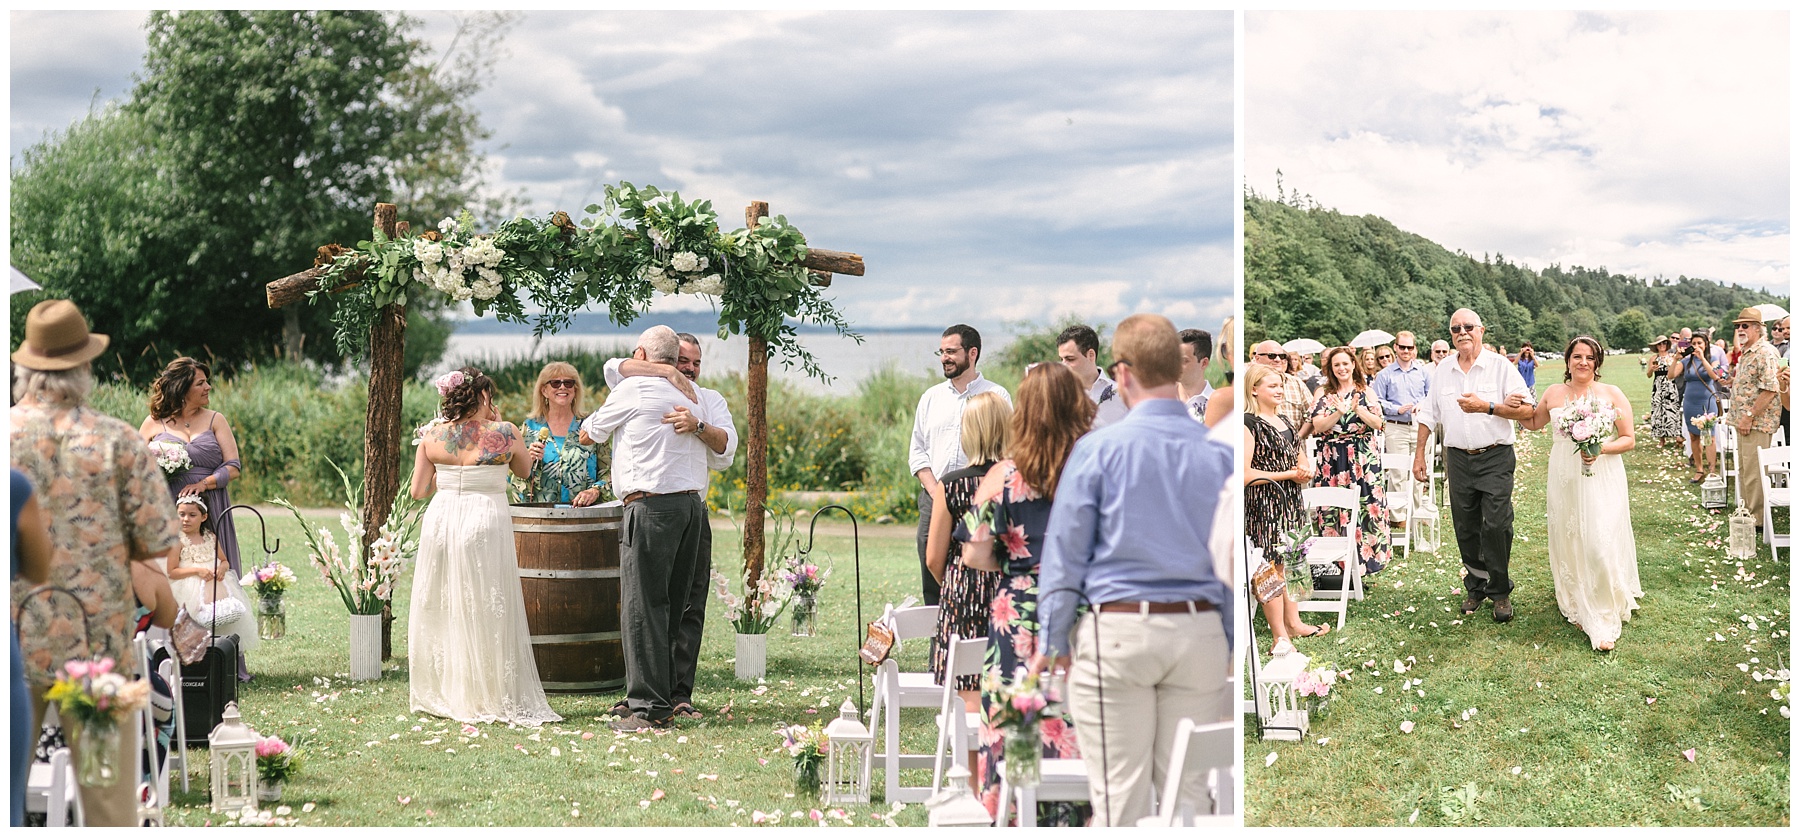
[1244,364,1330,652]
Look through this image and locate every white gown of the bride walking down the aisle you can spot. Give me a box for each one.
[1546,407,1643,648]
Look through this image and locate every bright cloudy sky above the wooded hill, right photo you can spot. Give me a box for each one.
[1244,13,1791,288]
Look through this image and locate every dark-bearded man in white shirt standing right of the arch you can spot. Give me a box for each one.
[907,324,1012,605]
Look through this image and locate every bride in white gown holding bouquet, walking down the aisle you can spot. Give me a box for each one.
[1523,337,1643,652]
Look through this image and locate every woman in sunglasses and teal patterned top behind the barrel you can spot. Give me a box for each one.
[518,360,612,506]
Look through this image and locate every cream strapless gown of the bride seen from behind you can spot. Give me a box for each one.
[407,464,562,727]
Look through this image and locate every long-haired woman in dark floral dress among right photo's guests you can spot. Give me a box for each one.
[1310,346,1391,576]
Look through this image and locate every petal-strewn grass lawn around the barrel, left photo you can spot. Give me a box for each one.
[167,508,936,826]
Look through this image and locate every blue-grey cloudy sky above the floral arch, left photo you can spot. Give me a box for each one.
[11,13,1235,328]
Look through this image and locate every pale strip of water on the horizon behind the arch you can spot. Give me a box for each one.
[430,331,1012,392]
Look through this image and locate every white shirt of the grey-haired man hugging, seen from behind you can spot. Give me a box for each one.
[581,378,709,500]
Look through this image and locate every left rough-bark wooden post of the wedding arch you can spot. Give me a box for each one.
[362,203,407,661]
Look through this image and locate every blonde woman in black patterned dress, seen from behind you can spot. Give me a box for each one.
[925,392,1012,691]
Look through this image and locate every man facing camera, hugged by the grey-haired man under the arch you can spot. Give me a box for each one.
[605,331,738,720]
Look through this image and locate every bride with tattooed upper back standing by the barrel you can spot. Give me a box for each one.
[407,367,562,727]
